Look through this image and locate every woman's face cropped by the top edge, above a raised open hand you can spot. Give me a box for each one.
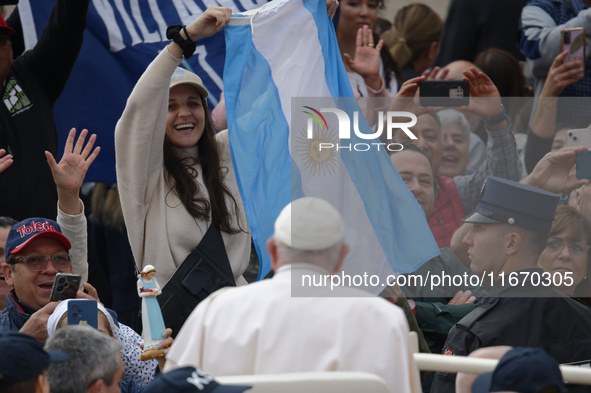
[337,0,378,37]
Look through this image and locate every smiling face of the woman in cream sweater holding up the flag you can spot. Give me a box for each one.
[166,85,205,147]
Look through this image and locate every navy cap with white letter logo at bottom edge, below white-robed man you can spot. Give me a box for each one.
[144,367,251,393]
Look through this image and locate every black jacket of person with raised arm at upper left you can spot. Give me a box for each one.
[0,0,90,220]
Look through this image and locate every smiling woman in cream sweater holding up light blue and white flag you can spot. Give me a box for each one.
[115,7,251,298]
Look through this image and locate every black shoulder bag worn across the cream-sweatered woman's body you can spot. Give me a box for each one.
[157,223,236,337]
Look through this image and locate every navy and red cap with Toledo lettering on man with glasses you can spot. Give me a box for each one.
[4,217,72,259]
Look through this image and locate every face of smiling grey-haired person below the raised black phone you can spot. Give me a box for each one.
[439,123,469,177]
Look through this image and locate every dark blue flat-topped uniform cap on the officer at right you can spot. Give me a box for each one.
[462,176,560,233]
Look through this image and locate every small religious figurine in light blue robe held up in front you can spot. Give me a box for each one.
[137,265,167,360]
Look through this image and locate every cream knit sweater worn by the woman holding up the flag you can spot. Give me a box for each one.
[115,49,251,285]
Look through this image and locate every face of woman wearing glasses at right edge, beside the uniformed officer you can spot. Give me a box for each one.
[538,229,589,296]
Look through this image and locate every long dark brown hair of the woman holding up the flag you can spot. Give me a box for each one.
[164,97,243,234]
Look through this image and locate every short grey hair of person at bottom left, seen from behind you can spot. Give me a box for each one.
[45,325,123,393]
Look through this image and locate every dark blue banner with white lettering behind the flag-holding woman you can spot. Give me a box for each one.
[18,0,266,182]
